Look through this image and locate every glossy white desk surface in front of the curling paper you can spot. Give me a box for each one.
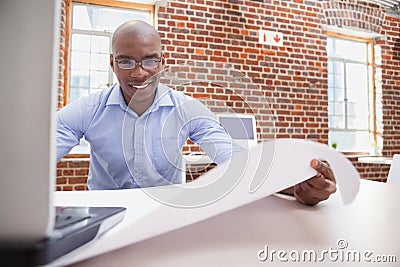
[67,180,400,267]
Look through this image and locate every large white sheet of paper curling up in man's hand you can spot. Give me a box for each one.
[53,139,360,265]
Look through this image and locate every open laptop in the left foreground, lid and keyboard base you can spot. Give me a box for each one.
[0,0,125,266]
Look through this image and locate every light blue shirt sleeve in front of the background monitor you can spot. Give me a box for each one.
[189,100,245,164]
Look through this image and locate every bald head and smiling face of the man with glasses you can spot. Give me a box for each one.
[110,21,162,116]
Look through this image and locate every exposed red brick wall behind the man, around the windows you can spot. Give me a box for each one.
[54,0,400,192]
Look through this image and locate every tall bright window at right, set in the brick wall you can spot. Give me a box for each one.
[327,36,377,152]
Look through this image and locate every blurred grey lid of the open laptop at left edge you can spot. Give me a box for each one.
[0,0,61,241]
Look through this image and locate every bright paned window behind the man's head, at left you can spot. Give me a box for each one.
[64,0,154,154]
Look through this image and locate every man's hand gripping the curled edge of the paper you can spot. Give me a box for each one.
[293,159,336,205]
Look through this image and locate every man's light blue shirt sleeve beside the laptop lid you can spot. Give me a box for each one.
[56,98,91,162]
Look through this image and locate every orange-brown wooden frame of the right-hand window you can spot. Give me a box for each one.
[326,31,379,153]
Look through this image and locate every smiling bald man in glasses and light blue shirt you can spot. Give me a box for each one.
[57,21,336,205]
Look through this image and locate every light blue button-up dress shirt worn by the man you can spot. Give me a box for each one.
[57,83,243,190]
